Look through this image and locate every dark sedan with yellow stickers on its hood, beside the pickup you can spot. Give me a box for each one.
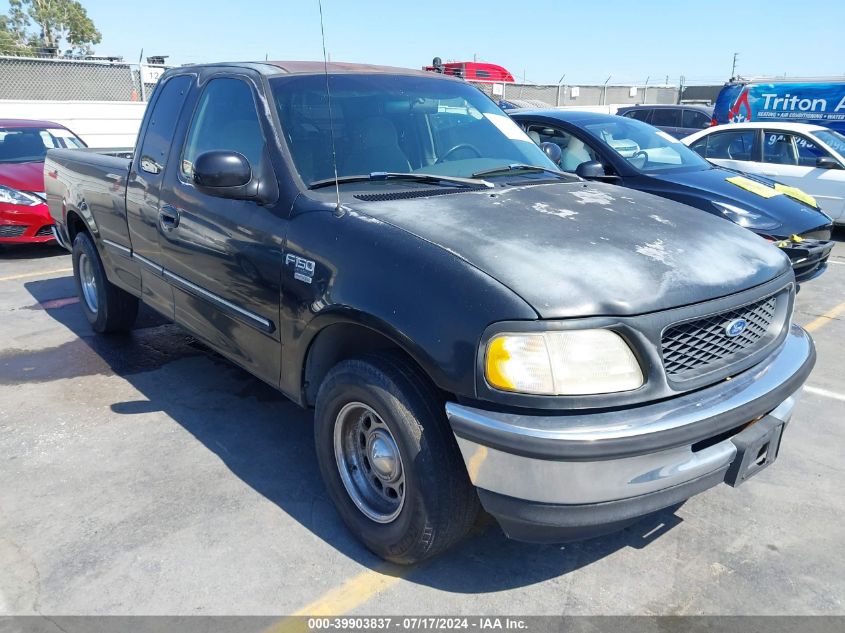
[508,110,833,281]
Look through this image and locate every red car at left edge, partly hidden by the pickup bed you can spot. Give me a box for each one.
[0,119,86,244]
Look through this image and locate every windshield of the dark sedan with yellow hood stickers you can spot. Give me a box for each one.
[584,117,710,173]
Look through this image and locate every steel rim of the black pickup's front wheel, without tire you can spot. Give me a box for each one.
[334,402,405,523]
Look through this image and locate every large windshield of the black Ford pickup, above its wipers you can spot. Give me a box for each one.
[270,73,555,185]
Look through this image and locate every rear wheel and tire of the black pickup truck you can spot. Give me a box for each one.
[72,231,138,333]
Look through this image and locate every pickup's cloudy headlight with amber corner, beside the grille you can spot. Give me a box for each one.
[484,330,643,396]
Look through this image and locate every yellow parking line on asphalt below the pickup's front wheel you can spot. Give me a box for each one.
[265,563,414,633]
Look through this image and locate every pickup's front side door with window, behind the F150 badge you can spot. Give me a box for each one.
[161,73,290,385]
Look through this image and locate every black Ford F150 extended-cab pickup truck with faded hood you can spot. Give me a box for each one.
[45,62,815,563]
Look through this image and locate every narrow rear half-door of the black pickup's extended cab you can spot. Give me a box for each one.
[126,75,195,318]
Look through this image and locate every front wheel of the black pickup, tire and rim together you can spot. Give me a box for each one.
[314,355,479,564]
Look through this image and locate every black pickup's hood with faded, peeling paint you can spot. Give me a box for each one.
[350,181,790,319]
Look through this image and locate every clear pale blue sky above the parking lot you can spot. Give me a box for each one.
[0,0,845,84]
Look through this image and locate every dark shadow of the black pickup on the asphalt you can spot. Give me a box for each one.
[21,276,682,594]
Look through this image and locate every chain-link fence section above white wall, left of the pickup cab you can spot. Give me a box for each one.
[0,56,166,101]
